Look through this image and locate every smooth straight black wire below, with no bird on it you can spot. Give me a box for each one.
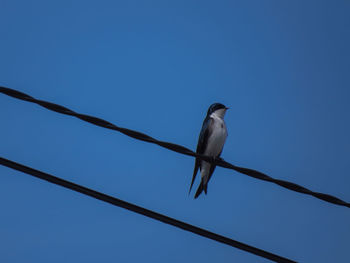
[0,157,295,263]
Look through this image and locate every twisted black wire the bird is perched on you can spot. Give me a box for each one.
[0,86,350,210]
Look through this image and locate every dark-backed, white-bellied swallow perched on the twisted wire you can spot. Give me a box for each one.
[189,103,229,199]
